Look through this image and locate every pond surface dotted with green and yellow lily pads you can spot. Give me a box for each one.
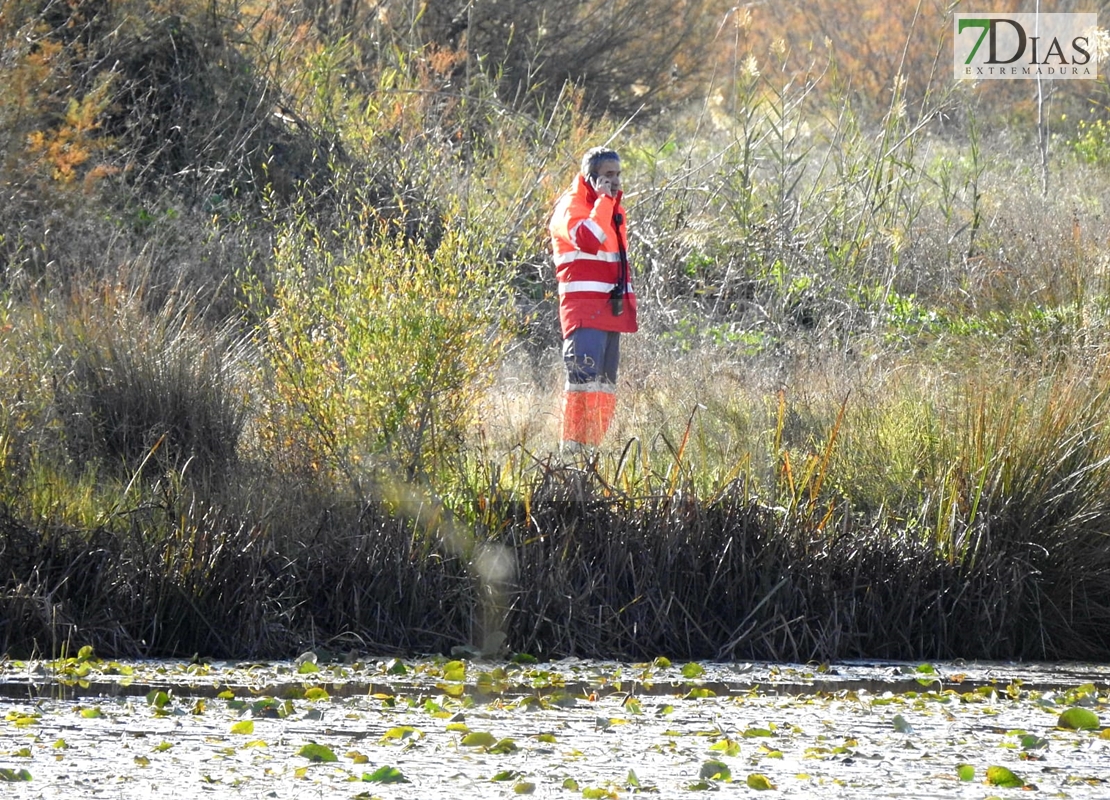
[0,650,1110,800]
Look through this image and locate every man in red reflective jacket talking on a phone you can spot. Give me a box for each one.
[549,148,637,453]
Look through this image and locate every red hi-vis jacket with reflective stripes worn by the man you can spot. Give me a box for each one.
[549,174,637,338]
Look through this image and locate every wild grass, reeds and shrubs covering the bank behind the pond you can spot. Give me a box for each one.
[0,0,1110,660]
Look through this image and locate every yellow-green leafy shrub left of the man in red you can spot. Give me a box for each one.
[254,215,509,486]
